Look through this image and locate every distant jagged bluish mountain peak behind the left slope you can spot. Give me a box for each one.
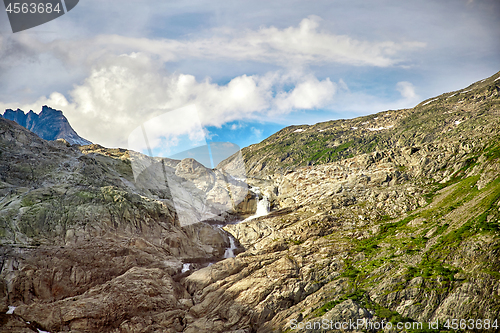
[3,105,92,145]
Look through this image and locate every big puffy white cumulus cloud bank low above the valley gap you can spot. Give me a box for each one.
[1,53,336,147]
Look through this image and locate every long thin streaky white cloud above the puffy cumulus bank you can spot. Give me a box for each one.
[10,15,425,67]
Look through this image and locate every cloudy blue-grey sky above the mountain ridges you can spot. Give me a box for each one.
[0,0,500,156]
